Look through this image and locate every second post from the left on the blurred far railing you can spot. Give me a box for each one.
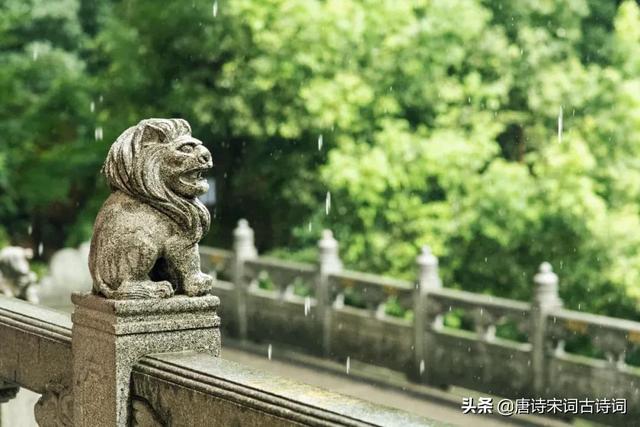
[316,230,342,357]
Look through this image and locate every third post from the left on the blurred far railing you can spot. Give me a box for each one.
[410,245,442,382]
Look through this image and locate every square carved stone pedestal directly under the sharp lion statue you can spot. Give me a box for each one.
[71,293,220,427]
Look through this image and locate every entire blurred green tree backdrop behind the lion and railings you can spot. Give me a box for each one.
[0,0,640,320]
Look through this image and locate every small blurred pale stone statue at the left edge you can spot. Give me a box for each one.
[0,246,38,302]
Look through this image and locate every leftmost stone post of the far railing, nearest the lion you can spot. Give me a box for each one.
[233,219,258,340]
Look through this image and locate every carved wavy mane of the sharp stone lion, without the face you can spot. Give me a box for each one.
[102,119,211,233]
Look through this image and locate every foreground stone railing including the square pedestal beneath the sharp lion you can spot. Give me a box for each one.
[0,295,436,427]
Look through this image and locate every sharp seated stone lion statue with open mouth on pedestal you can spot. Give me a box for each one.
[89,119,213,299]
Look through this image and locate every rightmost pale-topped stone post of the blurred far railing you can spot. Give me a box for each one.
[530,262,562,397]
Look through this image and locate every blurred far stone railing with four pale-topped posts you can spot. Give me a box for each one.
[201,220,640,423]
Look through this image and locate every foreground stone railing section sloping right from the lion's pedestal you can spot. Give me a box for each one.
[132,352,436,427]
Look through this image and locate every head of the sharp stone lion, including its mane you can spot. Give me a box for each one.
[102,119,213,232]
